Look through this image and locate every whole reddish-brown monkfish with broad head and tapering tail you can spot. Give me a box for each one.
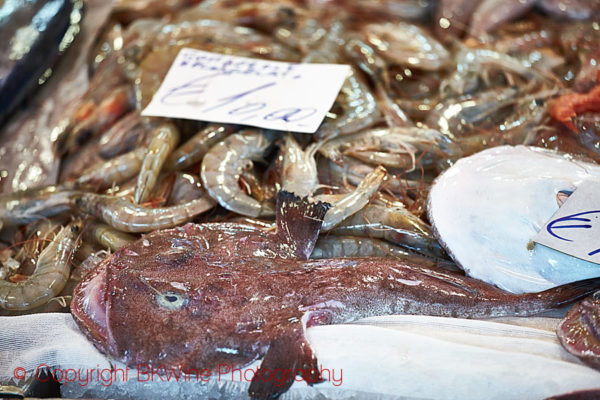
[71,194,600,398]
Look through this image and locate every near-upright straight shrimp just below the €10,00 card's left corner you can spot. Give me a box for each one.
[134,123,179,204]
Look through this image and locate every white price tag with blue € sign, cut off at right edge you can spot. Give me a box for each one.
[533,181,600,264]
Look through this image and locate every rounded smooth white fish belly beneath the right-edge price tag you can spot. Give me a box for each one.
[428,146,600,293]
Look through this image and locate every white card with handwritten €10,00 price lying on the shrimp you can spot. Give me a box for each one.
[142,48,350,133]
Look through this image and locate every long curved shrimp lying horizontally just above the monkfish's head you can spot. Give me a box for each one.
[71,193,215,233]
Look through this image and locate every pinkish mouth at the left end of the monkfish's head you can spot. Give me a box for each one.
[71,262,111,352]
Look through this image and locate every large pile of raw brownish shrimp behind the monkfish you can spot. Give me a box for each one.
[0,0,600,313]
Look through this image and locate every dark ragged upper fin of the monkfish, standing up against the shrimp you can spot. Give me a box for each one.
[277,190,331,260]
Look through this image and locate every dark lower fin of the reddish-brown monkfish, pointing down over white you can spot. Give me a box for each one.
[248,330,322,400]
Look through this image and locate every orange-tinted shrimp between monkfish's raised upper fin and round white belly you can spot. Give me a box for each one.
[331,202,446,258]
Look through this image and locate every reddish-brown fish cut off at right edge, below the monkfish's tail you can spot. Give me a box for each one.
[556,291,600,370]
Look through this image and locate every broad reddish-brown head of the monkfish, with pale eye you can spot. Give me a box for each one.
[71,247,276,370]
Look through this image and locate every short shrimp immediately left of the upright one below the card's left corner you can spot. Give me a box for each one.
[74,148,147,190]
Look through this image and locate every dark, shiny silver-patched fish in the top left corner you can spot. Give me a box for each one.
[0,0,83,126]
